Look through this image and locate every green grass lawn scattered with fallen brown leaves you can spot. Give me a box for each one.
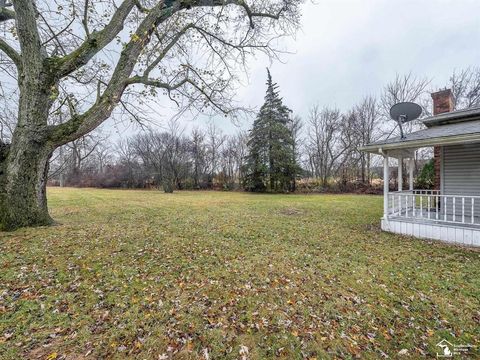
[0,188,480,360]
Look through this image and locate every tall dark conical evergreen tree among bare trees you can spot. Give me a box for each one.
[244,69,299,192]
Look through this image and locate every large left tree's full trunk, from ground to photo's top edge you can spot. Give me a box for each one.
[0,1,58,230]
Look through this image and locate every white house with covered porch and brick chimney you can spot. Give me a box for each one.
[361,90,480,246]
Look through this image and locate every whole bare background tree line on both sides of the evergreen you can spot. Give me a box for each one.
[41,68,480,192]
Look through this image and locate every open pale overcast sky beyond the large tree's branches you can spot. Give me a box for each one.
[110,0,480,137]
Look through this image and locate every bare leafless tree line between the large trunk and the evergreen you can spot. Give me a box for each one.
[49,121,246,192]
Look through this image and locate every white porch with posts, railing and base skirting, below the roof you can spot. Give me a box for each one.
[381,145,480,246]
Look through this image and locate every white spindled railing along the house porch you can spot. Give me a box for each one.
[387,190,480,225]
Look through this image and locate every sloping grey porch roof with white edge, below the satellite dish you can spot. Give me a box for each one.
[360,116,480,153]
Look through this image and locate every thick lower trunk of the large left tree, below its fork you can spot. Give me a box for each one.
[0,53,56,230]
